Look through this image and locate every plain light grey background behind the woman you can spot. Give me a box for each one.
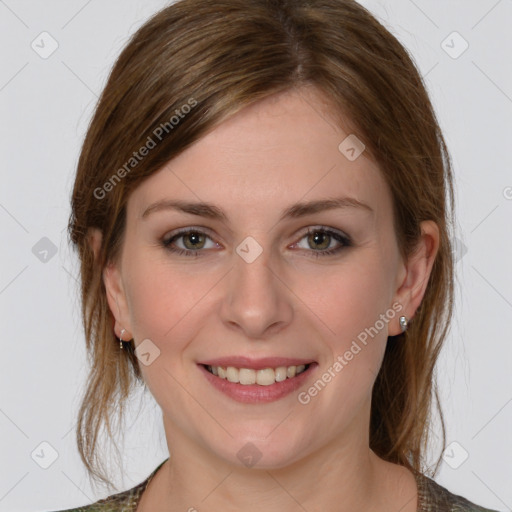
[0,0,512,512]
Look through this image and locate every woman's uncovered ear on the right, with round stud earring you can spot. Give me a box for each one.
[388,220,439,336]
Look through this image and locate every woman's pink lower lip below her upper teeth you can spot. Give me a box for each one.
[198,363,318,404]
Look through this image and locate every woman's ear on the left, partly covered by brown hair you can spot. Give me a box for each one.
[88,228,133,341]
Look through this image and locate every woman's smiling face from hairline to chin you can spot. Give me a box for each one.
[104,89,431,468]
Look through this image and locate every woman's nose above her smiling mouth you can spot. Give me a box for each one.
[221,240,293,339]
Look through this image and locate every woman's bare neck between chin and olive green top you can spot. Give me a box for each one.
[147,412,416,512]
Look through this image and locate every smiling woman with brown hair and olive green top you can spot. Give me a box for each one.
[54,0,498,512]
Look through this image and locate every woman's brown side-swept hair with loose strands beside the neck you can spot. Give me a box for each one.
[68,0,454,485]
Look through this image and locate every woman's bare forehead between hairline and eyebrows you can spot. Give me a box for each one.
[128,90,391,225]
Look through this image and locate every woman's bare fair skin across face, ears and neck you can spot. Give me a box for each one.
[92,88,439,512]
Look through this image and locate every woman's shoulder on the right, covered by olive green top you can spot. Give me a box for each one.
[416,473,498,512]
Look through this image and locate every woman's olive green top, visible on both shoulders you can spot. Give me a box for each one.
[51,458,498,512]
